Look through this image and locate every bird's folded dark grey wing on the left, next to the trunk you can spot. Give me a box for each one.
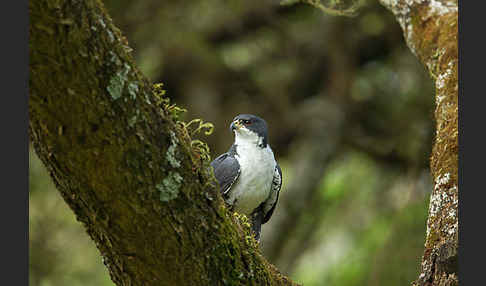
[211,146,240,199]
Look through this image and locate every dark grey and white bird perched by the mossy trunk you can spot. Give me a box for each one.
[210,114,282,242]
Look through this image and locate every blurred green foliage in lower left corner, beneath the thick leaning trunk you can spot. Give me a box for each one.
[29,150,113,286]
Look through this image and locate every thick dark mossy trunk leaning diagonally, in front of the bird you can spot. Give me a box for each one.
[29,0,294,285]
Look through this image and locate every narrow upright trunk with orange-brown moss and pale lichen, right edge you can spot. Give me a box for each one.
[380,0,459,285]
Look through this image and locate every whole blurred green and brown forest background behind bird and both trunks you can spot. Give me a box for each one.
[29,0,433,285]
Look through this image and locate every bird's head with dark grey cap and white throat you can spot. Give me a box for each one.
[230,114,268,147]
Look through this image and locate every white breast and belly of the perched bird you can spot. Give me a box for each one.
[229,142,276,215]
